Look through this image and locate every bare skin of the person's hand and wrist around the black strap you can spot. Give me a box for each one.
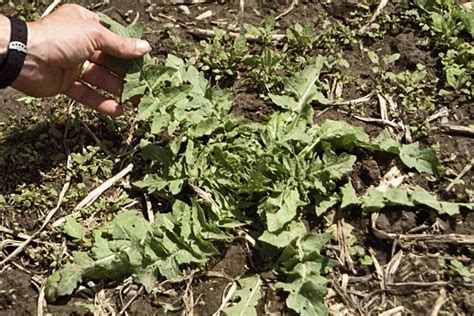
[0,4,150,117]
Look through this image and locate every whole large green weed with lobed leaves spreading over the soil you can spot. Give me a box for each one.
[42,15,472,315]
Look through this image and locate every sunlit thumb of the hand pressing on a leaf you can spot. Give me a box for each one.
[97,27,151,59]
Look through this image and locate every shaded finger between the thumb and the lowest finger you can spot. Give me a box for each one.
[81,63,123,96]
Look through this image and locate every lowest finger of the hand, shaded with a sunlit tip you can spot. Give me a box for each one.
[65,81,123,117]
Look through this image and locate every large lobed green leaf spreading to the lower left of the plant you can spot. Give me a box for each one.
[46,201,221,301]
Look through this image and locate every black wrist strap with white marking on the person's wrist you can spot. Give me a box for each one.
[0,17,28,89]
